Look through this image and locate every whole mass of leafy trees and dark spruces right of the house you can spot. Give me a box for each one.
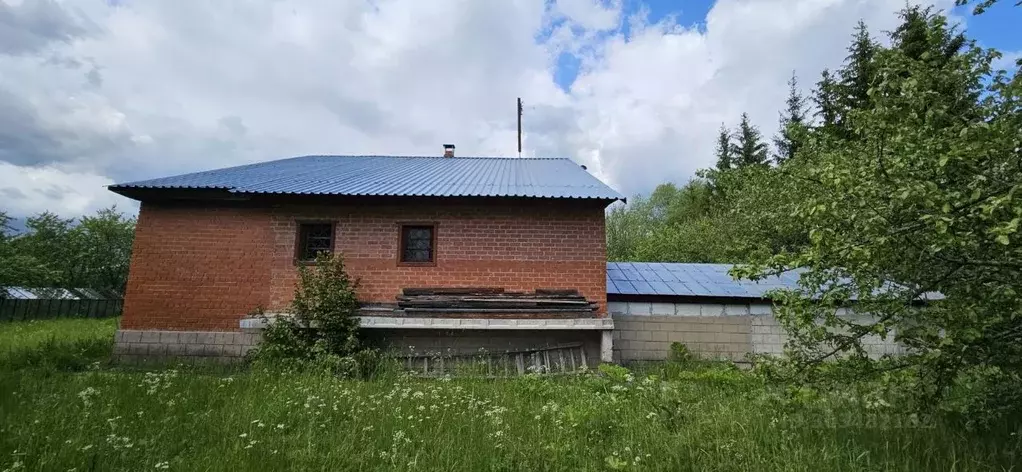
[608,7,1022,426]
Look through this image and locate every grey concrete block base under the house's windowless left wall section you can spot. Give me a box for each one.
[113,329,262,363]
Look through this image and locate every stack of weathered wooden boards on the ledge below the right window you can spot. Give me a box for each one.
[398,287,598,317]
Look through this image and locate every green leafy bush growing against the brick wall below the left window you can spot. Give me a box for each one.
[252,254,380,377]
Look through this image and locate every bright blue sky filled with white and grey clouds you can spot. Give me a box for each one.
[0,0,1022,217]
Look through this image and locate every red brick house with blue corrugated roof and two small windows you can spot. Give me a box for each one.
[109,150,623,363]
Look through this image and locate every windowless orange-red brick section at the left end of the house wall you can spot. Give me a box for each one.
[121,204,273,331]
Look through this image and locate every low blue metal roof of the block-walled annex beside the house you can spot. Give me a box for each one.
[607,263,798,298]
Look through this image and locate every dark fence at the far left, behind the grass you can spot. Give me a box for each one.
[0,298,124,322]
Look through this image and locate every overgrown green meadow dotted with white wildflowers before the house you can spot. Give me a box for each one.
[0,320,1022,471]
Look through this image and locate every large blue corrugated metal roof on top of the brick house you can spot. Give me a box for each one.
[109,155,624,200]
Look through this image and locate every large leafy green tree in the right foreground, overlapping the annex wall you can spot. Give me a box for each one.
[736,7,1022,418]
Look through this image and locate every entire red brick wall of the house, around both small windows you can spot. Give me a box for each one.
[122,200,606,330]
